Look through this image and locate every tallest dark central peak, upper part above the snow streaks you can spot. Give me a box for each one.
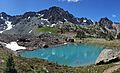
[38,6,78,24]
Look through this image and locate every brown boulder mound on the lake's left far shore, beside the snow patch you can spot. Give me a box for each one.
[17,33,64,50]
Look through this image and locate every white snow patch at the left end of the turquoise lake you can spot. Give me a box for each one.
[6,42,26,51]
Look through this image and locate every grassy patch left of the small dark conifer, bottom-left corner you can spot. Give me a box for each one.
[0,48,13,73]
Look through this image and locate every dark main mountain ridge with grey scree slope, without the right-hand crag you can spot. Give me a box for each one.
[0,6,93,34]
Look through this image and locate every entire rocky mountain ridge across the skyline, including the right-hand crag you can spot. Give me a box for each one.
[0,6,119,38]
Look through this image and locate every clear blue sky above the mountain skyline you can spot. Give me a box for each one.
[0,0,120,22]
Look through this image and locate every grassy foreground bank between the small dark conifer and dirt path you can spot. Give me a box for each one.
[14,57,119,73]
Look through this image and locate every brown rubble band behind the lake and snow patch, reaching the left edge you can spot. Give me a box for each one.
[0,33,65,50]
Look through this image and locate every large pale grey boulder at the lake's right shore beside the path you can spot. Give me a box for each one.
[95,49,118,65]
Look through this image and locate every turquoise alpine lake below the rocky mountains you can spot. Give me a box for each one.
[20,44,103,67]
